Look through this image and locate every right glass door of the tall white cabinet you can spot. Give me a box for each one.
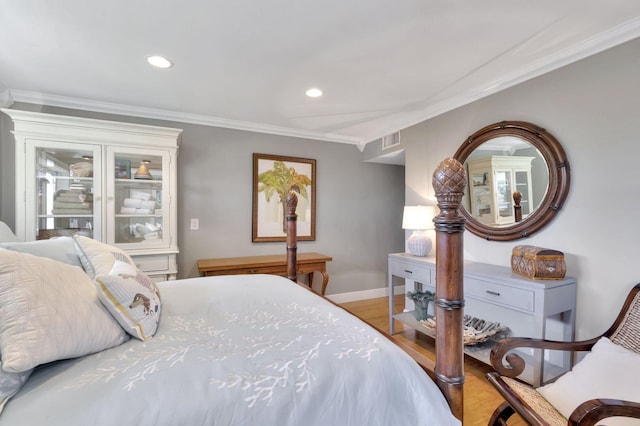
[107,147,170,249]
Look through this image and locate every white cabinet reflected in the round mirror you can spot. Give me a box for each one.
[467,155,534,225]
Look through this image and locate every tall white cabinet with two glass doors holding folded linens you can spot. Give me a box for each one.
[2,109,182,280]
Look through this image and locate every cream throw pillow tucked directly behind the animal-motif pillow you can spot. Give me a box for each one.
[73,235,135,279]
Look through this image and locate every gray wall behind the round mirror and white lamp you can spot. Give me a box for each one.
[401,39,640,338]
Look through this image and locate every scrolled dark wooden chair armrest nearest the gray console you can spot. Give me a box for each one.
[489,336,600,377]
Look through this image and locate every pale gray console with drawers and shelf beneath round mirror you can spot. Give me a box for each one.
[388,253,576,386]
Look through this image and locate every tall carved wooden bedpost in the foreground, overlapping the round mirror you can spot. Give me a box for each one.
[433,158,467,421]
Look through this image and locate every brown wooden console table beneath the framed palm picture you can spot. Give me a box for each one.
[198,253,333,296]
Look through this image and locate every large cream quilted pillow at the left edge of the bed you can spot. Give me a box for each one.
[0,249,128,372]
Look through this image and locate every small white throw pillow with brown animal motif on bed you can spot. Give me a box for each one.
[96,261,162,340]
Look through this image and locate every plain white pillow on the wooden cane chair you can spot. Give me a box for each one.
[537,337,640,426]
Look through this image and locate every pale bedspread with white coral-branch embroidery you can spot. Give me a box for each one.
[0,275,459,426]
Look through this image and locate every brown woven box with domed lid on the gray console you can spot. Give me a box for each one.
[511,246,567,280]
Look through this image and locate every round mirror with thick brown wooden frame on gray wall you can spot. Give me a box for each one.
[454,121,570,241]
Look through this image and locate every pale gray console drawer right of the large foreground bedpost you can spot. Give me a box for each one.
[464,278,535,312]
